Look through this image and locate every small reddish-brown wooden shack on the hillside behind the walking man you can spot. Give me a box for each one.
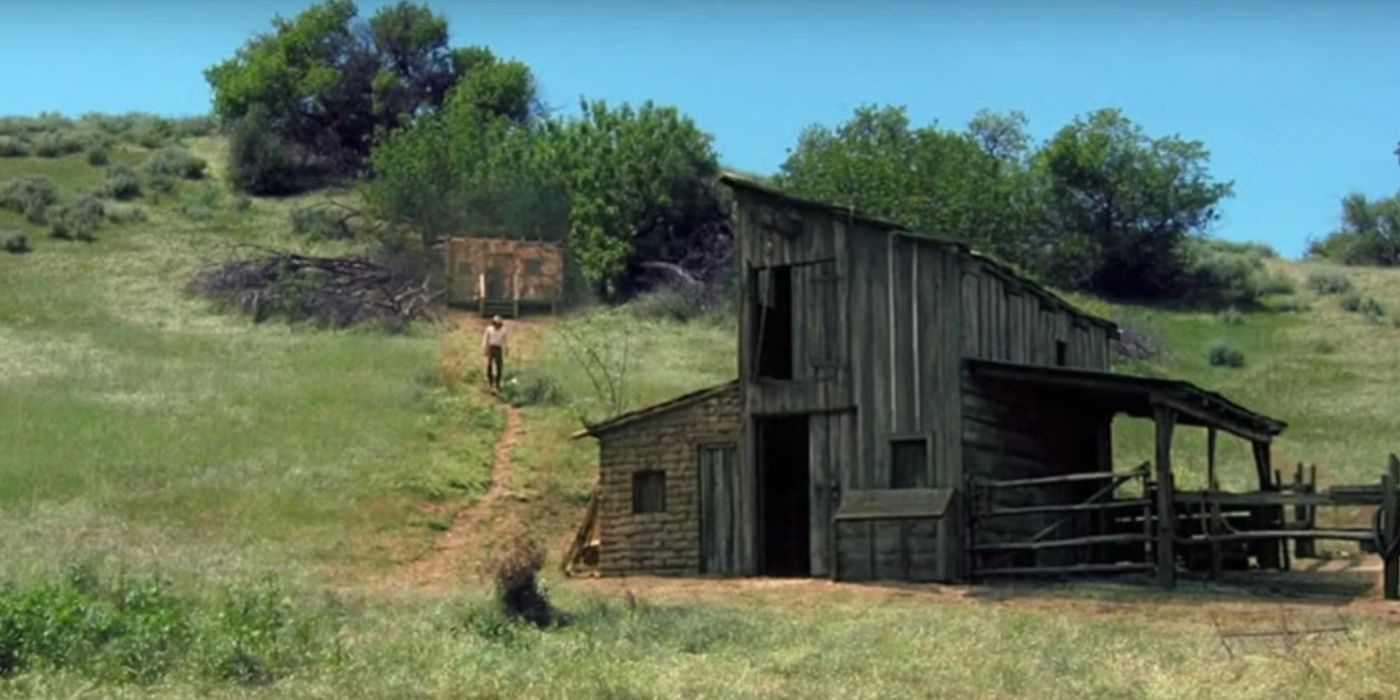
[440,237,564,316]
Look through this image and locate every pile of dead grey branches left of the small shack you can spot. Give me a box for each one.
[190,252,437,329]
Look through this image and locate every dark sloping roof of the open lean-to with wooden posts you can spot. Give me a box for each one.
[967,360,1288,441]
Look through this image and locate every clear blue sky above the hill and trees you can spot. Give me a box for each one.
[0,0,1400,256]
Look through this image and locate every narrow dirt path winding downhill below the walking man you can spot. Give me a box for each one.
[392,402,522,589]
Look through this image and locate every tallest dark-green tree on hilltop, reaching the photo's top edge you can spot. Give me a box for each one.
[204,0,533,192]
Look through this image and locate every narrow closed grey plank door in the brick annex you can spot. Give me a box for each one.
[700,445,742,575]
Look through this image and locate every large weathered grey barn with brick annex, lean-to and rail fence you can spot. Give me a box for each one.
[580,176,1396,585]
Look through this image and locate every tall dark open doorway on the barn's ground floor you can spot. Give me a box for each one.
[755,416,812,577]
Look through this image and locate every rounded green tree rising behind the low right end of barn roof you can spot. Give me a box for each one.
[1033,109,1232,298]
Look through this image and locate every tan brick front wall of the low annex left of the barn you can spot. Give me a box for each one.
[598,386,753,575]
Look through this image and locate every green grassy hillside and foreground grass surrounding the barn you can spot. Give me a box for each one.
[0,139,1400,699]
